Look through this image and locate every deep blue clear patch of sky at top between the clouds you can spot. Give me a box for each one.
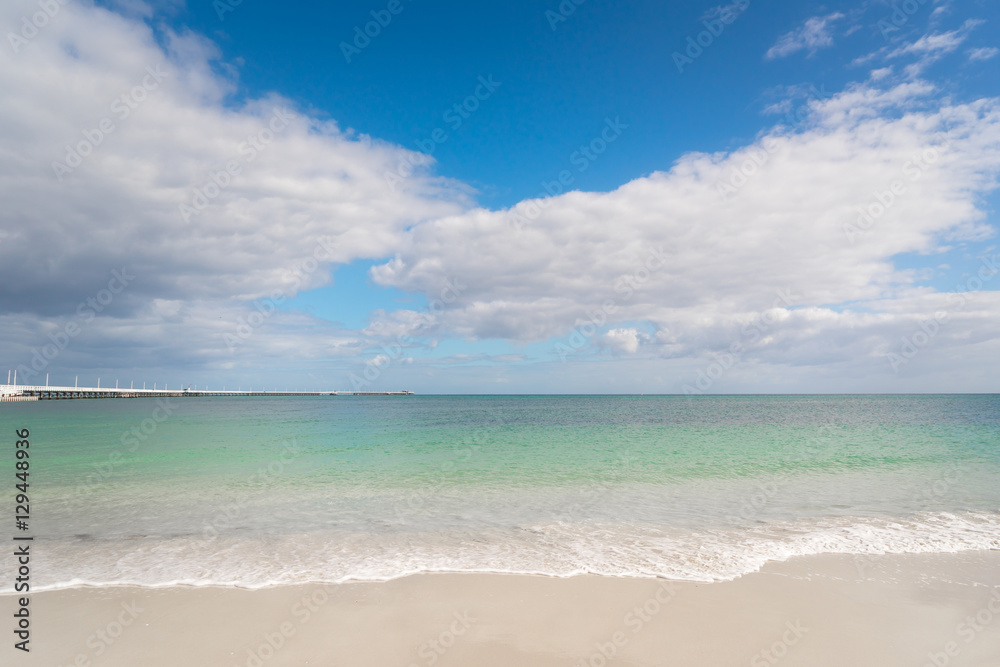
[172,0,964,207]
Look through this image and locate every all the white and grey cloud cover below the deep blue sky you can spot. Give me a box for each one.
[0,3,1000,391]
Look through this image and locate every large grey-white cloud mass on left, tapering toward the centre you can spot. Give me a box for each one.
[0,2,467,376]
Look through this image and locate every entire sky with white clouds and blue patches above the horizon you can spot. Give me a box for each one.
[0,0,1000,393]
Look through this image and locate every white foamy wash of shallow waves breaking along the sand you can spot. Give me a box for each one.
[13,512,1000,595]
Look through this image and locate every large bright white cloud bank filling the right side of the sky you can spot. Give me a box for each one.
[372,82,1000,376]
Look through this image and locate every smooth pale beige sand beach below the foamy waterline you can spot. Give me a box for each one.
[13,550,1000,667]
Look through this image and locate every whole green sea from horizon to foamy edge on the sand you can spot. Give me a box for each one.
[0,395,1000,590]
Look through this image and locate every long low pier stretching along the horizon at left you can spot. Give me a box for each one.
[0,384,413,402]
